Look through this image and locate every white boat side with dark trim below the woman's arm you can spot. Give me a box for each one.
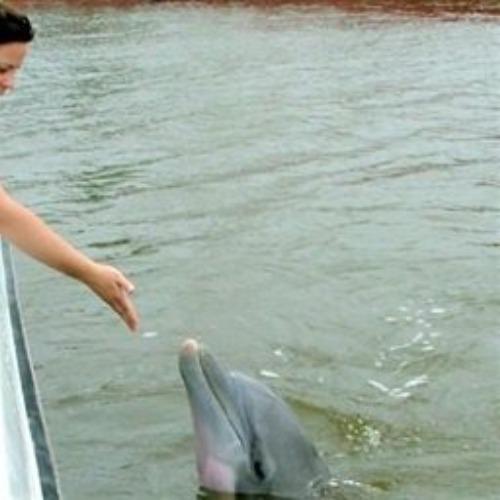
[0,240,61,500]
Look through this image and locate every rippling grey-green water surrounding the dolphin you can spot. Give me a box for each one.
[0,4,500,500]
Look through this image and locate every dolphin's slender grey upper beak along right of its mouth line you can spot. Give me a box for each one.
[198,350,247,450]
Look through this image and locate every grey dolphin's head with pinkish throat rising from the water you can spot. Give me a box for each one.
[179,340,330,499]
